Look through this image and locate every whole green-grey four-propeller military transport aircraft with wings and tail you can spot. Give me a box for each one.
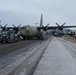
[0,14,76,39]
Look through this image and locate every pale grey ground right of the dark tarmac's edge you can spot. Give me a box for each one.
[34,38,76,75]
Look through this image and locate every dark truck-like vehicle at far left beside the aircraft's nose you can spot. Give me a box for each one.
[0,29,20,43]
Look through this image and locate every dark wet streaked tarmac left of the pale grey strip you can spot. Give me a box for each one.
[0,35,50,75]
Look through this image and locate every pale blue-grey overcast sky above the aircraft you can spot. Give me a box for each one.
[0,0,76,26]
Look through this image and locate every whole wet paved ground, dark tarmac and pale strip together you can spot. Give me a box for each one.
[0,37,76,75]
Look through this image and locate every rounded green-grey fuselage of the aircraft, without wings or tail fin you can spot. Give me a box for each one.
[20,25,43,38]
